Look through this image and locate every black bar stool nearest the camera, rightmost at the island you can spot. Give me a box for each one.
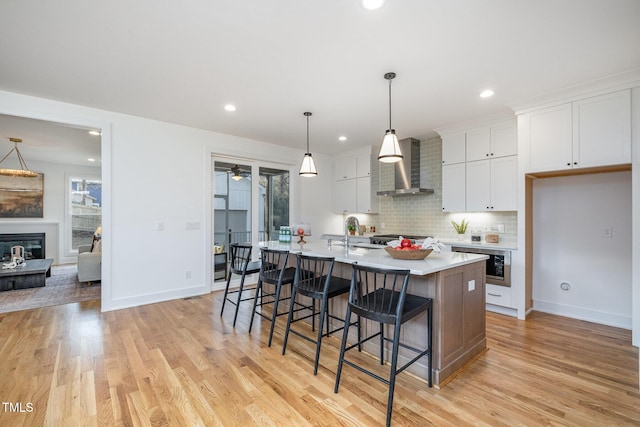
[334,264,433,426]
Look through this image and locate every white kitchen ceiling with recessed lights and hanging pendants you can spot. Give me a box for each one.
[0,0,640,162]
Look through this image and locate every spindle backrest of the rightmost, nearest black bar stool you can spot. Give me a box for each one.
[349,264,410,323]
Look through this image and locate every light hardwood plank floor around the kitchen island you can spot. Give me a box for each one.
[0,293,640,426]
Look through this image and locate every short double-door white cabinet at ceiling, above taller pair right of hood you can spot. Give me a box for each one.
[467,120,518,162]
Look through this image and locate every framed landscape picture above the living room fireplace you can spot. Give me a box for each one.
[0,173,44,218]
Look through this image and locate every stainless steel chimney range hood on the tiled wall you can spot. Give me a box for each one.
[376,138,434,196]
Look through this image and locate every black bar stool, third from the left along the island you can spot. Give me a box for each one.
[282,255,360,375]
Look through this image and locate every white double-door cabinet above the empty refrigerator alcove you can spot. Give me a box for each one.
[518,90,631,172]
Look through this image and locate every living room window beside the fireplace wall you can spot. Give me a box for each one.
[69,178,102,250]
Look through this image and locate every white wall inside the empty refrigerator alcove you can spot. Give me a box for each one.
[533,172,631,329]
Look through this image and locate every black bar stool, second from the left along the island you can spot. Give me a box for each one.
[249,248,296,347]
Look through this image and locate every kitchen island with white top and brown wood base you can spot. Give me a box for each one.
[258,242,487,387]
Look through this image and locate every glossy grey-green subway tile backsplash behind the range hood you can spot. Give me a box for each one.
[369,137,517,245]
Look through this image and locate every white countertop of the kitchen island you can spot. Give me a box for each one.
[258,241,488,276]
